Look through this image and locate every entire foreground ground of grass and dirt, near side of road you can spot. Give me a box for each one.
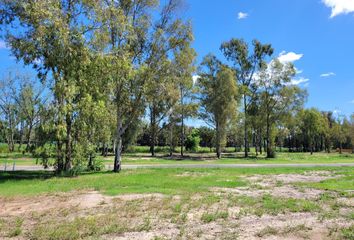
[0,167,354,239]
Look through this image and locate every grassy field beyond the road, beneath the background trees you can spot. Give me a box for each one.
[0,152,354,168]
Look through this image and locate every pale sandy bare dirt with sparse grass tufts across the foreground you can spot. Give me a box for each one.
[0,172,354,240]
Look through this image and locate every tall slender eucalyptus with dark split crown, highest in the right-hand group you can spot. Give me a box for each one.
[220,39,273,157]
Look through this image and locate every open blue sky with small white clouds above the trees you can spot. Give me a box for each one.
[0,0,354,120]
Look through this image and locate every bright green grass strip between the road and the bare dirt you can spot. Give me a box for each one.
[0,167,354,198]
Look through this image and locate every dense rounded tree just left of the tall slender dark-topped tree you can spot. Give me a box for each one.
[198,55,238,158]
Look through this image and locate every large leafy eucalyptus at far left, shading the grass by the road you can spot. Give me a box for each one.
[0,0,90,171]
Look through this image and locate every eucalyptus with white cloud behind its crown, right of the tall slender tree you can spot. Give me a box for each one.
[256,59,306,158]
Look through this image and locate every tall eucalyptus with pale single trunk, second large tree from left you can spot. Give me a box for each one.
[92,0,192,172]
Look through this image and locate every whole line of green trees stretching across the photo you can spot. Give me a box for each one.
[0,0,354,172]
